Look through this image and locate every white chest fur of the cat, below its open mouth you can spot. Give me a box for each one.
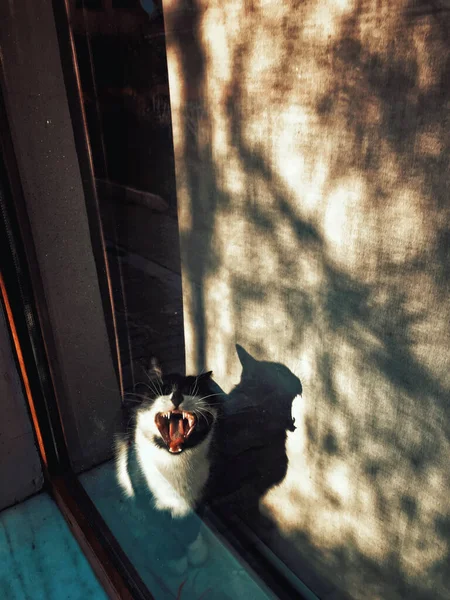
[135,428,211,517]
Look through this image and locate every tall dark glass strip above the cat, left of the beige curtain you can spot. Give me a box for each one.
[73,0,184,389]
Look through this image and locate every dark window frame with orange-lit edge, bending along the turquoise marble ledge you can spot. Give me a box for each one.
[0,48,153,600]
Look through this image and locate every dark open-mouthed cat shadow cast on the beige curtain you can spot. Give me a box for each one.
[209,345,302,529]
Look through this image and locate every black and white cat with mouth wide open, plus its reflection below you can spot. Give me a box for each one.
[116,359,223,571]
